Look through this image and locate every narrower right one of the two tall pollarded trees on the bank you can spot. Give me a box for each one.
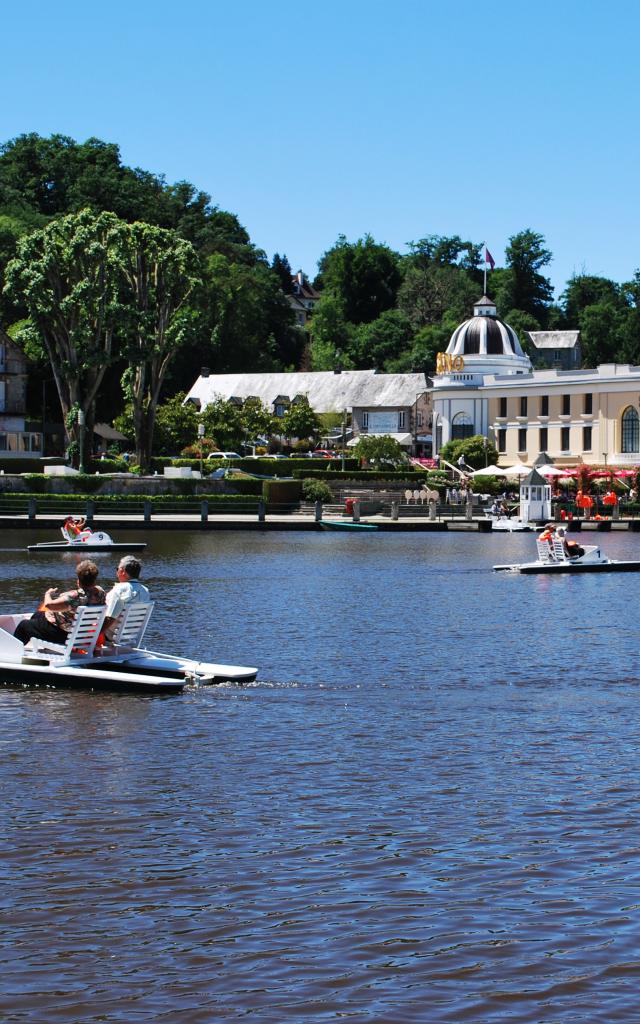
[120,223,200,470]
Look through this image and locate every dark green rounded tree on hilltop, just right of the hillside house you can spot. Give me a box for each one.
[316,234,400,324]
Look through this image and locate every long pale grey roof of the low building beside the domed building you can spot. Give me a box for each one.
[186,370,426,413]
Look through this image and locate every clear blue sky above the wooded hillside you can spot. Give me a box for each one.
[0,0,640,296]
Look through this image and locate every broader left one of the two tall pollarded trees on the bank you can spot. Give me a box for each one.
[5,211,124,466]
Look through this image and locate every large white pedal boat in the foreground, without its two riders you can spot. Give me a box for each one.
[0,603,258,693]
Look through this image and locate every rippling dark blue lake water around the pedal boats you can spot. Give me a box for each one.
[0,530,640,1024]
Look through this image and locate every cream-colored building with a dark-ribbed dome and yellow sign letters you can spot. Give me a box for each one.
[433,296,640,466]
